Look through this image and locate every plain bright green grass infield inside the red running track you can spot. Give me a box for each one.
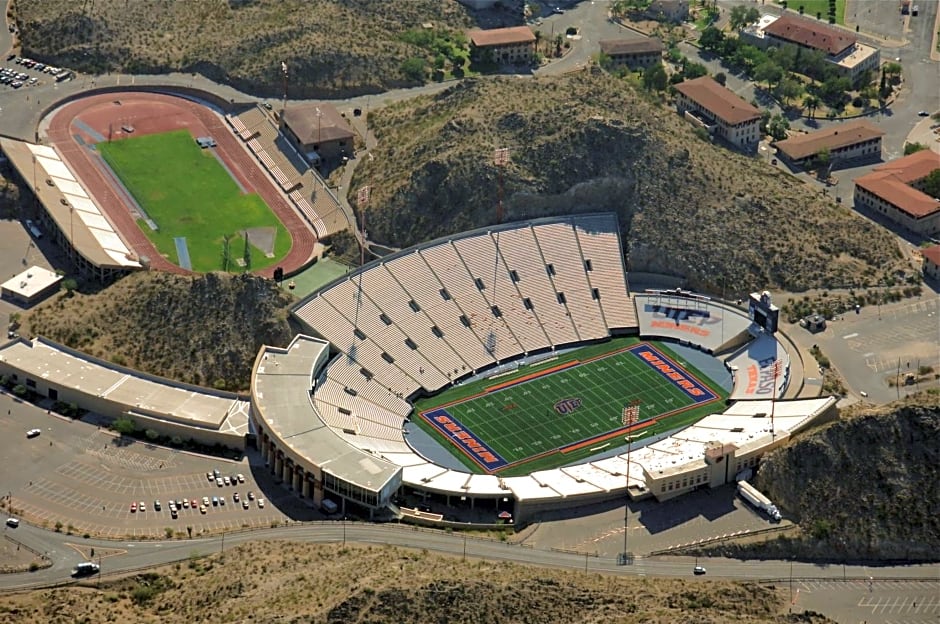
[96,130,291,272]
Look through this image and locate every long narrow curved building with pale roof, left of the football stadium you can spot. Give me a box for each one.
[0,338,249,435]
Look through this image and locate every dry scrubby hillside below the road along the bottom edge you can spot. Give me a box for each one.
[0,542,831,624]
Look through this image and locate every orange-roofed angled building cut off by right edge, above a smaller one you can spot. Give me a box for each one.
[855,150,940,236]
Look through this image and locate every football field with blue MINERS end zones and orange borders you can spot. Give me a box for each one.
[413,338,727,476]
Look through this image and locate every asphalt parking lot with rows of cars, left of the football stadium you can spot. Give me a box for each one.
[0,395,316,538]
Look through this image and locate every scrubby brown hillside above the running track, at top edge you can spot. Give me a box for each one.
[13,0,478,98]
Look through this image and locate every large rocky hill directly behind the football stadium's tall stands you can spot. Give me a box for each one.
[350,71,910,294]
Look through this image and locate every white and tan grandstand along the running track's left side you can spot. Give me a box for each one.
[0,138,141,269]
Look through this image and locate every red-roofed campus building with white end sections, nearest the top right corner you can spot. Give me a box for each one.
[739,13,881,83]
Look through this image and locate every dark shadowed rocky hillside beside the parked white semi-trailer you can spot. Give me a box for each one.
[703,392,940,561]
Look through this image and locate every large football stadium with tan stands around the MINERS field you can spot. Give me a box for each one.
[251,214,835,524]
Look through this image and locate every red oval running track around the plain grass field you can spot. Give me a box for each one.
[47,92,317,277]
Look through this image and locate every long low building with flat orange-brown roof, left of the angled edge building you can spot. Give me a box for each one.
[774,119,885,169]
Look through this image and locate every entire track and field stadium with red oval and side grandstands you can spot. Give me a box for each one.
[0,89,330,281]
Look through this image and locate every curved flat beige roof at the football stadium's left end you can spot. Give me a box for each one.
[251,334,401,491]
